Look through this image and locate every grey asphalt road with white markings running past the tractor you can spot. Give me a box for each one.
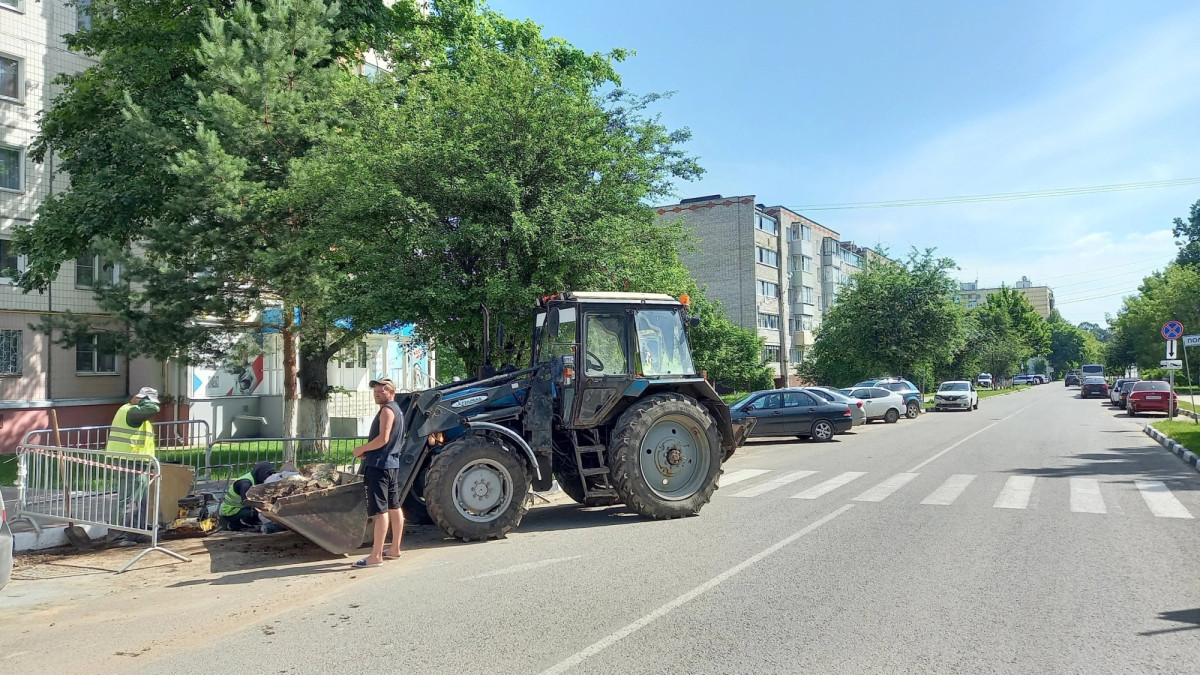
[136,384,1200,674]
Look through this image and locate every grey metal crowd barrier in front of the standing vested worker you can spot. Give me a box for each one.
[17,444,188,573]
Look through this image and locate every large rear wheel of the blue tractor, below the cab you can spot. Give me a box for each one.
[608,394,722,520]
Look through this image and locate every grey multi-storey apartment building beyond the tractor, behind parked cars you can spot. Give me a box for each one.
[658,195,876,384]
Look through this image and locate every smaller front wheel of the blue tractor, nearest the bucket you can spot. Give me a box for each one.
[425,436,529,542]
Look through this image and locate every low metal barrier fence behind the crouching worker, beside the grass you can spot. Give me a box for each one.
[208,436,367,476]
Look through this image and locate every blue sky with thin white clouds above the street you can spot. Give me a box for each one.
[490,0,1200,328]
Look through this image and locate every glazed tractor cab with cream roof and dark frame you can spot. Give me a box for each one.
[532,292,703,428]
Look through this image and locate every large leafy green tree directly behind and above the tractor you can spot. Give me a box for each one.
[293,5,700,370]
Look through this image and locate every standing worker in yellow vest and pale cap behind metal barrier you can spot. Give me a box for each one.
[104,387,158,542]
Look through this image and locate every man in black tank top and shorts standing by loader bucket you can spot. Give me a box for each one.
[354,378,404,567]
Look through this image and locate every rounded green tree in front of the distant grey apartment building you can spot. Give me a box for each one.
[798,249,965,386]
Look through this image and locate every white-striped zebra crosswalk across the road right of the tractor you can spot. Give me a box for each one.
[719,468,1194,519]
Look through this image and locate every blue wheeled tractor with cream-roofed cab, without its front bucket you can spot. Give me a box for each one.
[397,292,754,540]
